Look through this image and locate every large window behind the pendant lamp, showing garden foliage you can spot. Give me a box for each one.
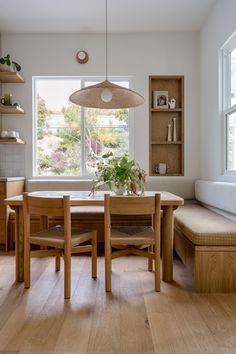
[33,77,130,177]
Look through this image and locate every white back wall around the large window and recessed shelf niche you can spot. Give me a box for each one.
[2,33,199,198]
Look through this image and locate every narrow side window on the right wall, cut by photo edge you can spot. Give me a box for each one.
[223,34,236,173]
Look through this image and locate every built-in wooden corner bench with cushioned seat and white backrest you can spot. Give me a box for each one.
[174,181,236,293]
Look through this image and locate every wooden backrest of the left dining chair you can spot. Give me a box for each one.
[23,192,71,238]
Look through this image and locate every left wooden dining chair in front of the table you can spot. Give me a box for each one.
[23,192,97,299]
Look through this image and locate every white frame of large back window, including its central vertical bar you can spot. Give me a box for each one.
[31,75,134,181]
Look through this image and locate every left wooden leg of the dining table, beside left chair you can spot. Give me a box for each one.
[14,206,24,281]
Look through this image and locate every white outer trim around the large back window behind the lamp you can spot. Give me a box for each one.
[30,76,134,181]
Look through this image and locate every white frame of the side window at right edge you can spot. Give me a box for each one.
[222,32,236,177]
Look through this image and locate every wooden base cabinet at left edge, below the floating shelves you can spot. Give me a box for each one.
[0,177,25,251]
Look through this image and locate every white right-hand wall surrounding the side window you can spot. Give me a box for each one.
[200,0,236,182]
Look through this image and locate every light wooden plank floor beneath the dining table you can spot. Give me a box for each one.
[0,256,236,354]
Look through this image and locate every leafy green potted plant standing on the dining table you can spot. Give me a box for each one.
[91,152,146,195]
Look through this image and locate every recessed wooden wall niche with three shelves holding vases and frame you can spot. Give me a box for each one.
[149,75,184,176]
